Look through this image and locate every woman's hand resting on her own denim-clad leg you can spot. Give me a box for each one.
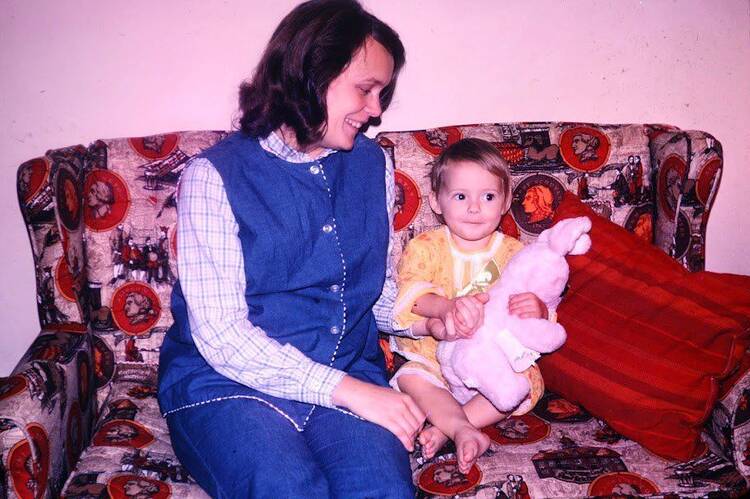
[333,375,426,452]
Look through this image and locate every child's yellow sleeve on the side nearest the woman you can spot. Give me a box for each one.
[393,236,445,329]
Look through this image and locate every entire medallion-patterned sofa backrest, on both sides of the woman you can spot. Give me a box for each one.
[18,123,722,378]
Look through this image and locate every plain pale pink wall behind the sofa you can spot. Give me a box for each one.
[0,0,750,375]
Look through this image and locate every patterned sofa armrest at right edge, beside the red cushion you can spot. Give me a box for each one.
[705,366,750,483]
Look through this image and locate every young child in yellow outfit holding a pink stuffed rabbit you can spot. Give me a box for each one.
[391,139,548,473]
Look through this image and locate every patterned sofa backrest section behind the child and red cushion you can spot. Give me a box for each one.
[377,123,723,271]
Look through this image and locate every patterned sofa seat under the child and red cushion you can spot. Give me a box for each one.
[412,386,747,498]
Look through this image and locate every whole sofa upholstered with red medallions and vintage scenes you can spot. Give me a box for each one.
[0,123,750,498]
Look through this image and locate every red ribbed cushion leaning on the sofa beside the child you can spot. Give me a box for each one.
[539,193,750,460]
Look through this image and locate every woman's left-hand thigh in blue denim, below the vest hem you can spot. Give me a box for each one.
[167,400,329,497]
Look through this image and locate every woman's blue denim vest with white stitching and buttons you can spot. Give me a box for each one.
[158,133,389,430]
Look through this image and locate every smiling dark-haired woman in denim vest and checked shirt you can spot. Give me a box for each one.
[159,0,425,497]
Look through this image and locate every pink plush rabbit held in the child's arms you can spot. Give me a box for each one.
[437,217,591,412]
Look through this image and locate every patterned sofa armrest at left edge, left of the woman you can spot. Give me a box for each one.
[0,331,95,497]
